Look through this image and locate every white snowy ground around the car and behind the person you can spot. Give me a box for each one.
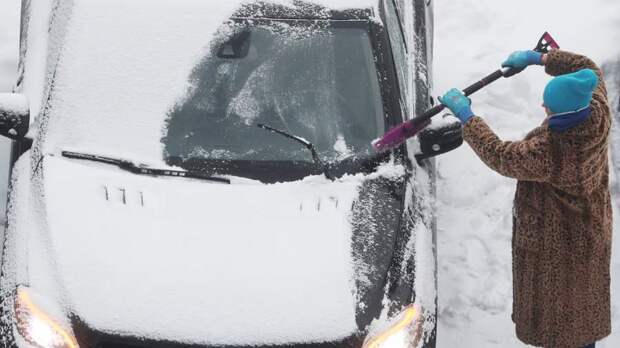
[0,0,620,348]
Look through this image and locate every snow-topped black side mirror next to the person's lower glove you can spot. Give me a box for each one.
[415,116,463,162]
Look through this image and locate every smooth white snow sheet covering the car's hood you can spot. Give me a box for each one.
[44,156,359,344]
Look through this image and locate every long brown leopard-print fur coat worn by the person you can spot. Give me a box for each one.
[463,50,612,348]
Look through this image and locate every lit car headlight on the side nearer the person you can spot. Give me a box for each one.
[363,305,423,348]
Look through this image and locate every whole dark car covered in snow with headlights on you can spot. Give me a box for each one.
[0,0,454,348]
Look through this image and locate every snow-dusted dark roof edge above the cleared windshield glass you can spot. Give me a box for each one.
[233,0,377,20]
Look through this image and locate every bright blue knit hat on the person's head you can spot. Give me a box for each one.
[543,69,598,114]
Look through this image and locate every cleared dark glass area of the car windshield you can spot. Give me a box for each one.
[163,21,385,163]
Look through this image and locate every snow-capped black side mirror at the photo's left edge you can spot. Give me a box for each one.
[0,93,30,140]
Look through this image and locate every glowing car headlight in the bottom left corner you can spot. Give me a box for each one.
[15,287,79,348]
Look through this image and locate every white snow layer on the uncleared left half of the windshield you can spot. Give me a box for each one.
[44,0,380,165]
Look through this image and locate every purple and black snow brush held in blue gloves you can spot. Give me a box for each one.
[372,32,560,152]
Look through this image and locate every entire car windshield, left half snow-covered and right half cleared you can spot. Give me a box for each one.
[44,0,397,182]
